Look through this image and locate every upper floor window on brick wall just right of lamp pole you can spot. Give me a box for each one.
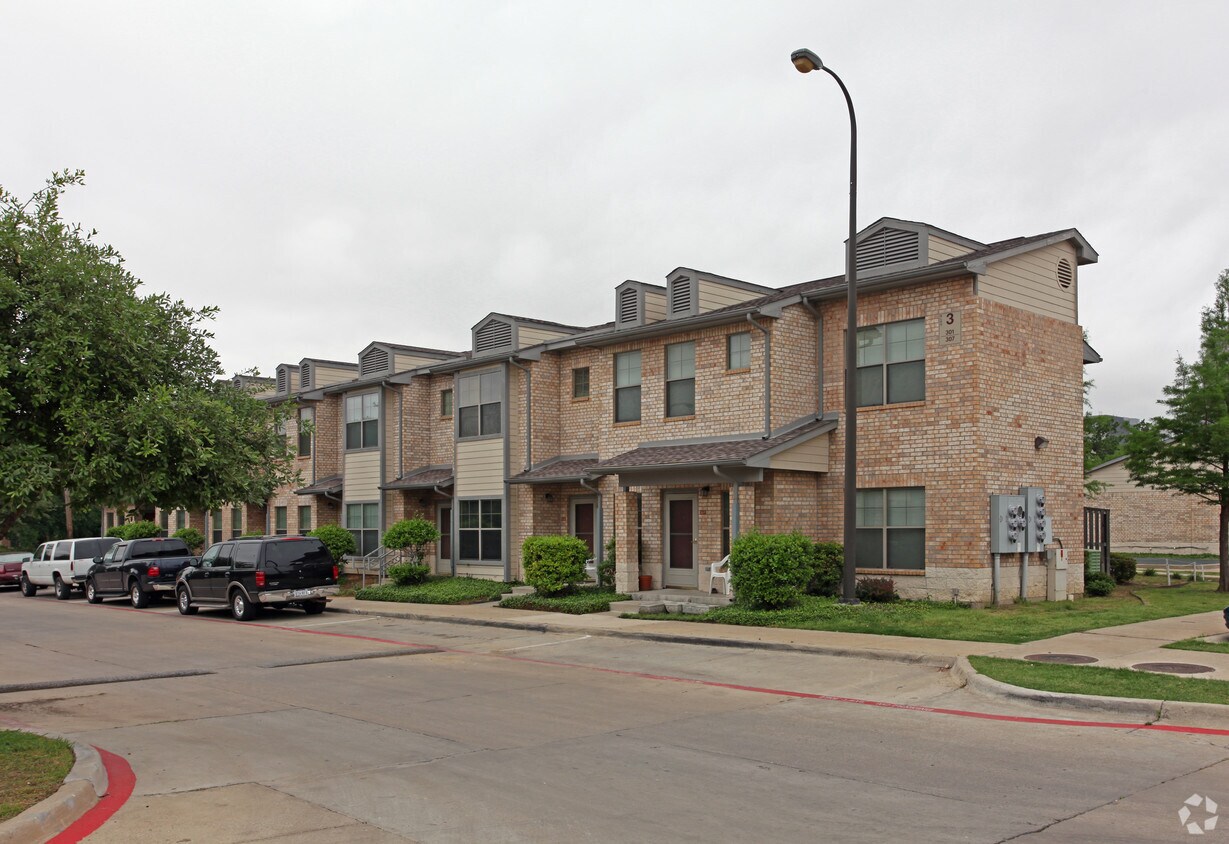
[858,319,925,407]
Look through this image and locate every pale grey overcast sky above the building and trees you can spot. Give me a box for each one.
[9,0,1229,416]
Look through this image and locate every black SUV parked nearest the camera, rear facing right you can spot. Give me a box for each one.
[175,537,338,622]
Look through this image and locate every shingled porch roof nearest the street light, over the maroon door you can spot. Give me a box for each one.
[590,416,837,486]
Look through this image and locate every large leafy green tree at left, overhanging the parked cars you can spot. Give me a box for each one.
[0,171,294,537]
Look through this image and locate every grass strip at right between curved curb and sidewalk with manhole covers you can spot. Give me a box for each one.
[968,656,1229,704]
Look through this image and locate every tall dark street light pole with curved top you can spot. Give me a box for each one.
[789,49,858,603]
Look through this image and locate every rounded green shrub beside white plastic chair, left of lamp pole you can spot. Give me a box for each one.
[730,531,815,609]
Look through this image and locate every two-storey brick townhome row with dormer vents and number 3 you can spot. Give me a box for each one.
[108,217,1096,601]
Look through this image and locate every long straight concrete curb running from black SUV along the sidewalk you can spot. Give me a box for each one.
[328,604,952,668]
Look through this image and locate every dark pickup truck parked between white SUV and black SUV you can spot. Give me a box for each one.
[85,538,197,609]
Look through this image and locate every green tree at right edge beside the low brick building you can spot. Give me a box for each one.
[1127,269,1229,592]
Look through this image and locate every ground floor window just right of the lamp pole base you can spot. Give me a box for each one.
[857,486,925,570]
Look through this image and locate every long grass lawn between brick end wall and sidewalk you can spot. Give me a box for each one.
[635,577,1229,644]
